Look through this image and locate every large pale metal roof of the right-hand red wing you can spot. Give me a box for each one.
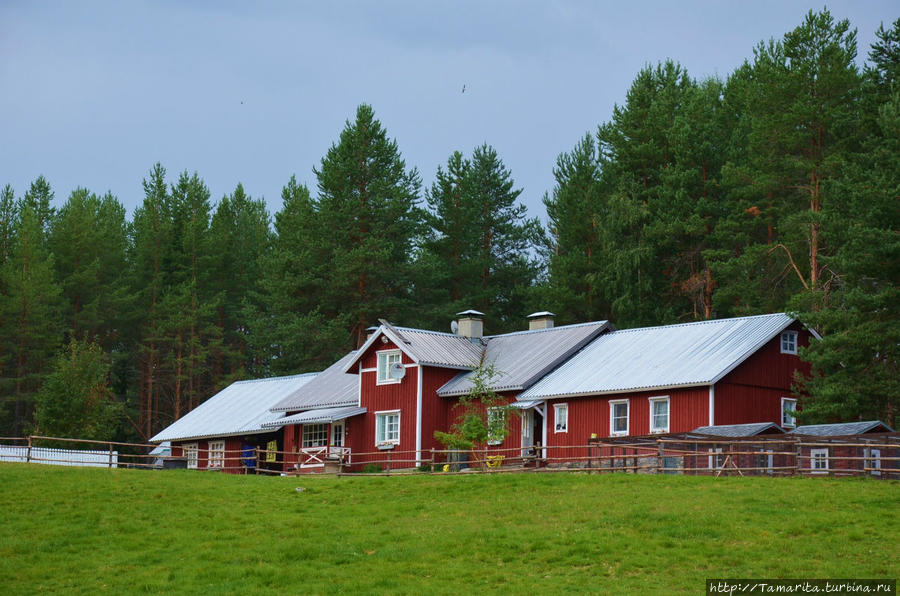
[519,313,794,401]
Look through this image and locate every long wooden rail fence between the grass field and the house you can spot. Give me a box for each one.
[0,433,900,479]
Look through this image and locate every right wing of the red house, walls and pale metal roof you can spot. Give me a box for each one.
[517,314,814,458]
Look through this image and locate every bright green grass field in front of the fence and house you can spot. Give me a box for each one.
[0,464,900,595]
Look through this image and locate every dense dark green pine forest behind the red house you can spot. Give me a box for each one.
[0,10,900,440]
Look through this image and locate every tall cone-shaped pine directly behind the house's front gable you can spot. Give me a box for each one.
[315,104,422,347]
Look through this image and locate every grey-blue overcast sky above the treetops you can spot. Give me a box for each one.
[0,0,900,221]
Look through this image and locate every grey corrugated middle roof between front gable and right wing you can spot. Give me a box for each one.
[438,321,609,397]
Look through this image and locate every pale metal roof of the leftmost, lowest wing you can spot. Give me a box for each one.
[150,373,317,443]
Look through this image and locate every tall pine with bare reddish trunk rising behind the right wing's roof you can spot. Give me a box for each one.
[719,10,860,311]
